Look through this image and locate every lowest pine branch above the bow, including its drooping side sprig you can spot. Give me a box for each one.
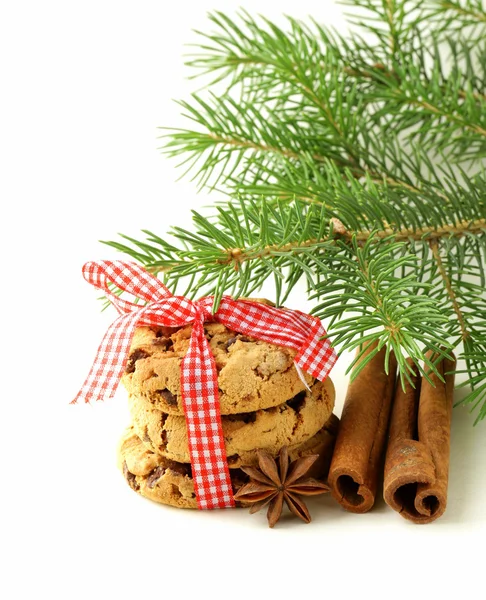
[108,190,486,420]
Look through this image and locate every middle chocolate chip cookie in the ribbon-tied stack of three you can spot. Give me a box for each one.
[128,378,334,468]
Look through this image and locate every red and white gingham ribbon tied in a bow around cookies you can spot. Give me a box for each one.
[73,261,337,509]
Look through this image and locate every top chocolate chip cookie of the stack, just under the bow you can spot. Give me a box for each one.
[122,323,314,415]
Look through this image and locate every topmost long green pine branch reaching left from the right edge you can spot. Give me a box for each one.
[180,6,486,161]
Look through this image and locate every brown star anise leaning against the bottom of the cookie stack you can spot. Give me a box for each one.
[235,446,329,527]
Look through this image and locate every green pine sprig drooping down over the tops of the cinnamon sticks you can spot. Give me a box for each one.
[311,232,450,384]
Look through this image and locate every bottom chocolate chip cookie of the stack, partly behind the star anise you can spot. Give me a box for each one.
[118,415,337,508]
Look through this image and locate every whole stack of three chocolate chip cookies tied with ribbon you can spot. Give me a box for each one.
[118,316,338,508]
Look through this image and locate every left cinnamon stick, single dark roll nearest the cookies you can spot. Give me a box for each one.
[328,344,397,513]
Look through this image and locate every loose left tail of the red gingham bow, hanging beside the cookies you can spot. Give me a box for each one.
[71,312,141,404]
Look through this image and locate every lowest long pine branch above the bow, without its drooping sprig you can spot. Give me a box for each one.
[103,196,484,347]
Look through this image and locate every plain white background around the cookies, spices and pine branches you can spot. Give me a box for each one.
[0,0,486,600]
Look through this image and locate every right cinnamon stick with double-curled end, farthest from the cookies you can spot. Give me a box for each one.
[384,353,456,523]
